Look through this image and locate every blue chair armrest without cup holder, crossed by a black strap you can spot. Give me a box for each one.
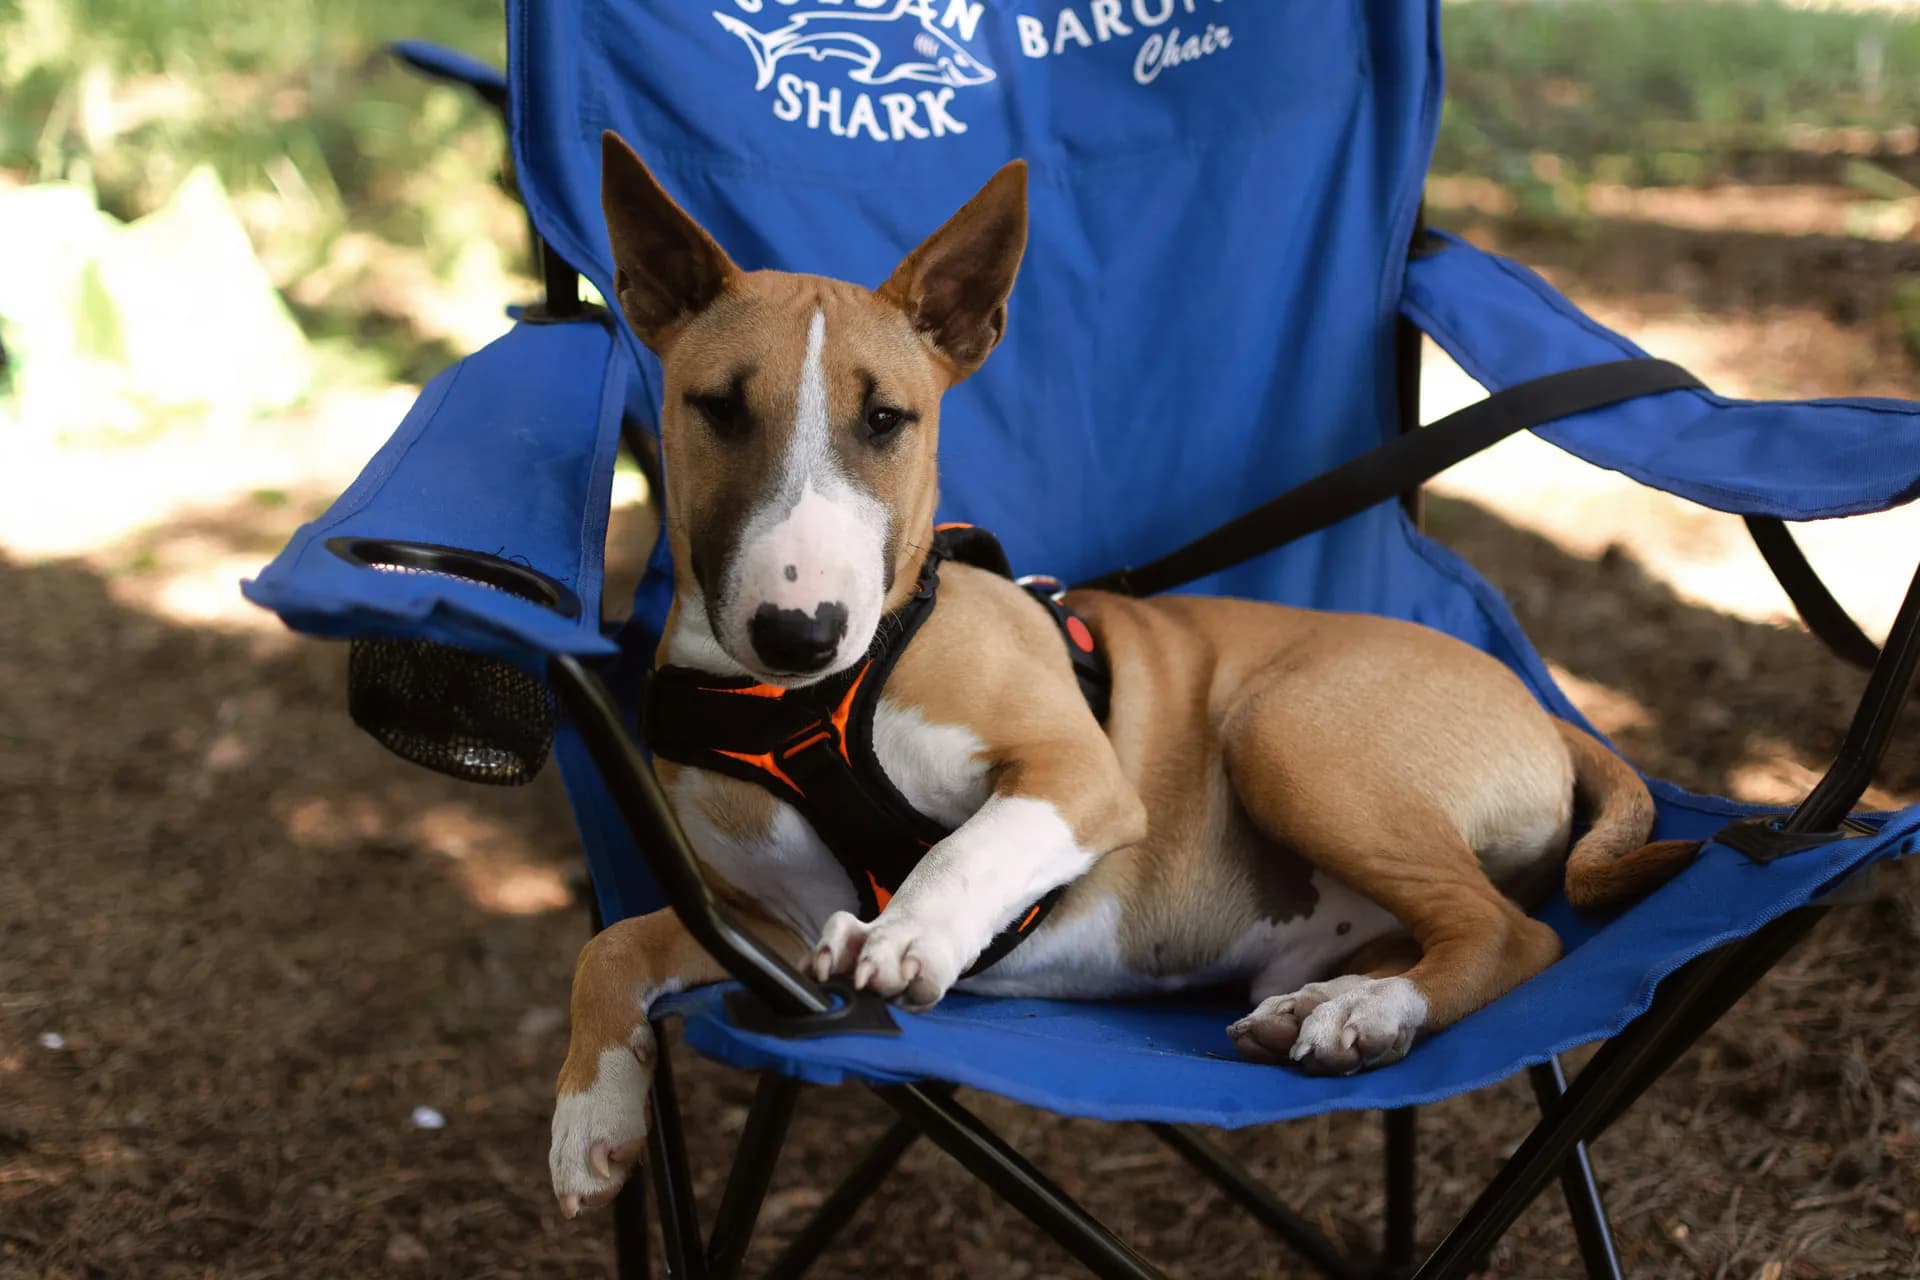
[1400,232,1920,520]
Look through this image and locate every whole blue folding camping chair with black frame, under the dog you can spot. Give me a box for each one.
[246,0,1920,1278]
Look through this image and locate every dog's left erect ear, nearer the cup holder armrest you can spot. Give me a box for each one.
[601,129,739,351]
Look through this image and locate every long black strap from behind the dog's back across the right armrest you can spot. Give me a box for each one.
[1075,357,1705,595]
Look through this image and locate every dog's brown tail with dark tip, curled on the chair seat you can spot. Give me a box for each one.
[1553,720,1699,908]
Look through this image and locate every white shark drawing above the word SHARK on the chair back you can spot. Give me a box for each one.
[714,0,993,90]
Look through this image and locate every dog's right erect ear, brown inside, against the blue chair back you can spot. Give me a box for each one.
[876,159,1027,382]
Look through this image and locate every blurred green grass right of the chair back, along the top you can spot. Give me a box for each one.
[1434,0,1920,192]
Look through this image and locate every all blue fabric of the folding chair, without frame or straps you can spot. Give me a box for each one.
[250,0,1920,1125]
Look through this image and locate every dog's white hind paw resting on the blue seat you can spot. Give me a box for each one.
[1227,973,1427,1075]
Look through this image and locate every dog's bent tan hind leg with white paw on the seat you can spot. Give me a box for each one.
[1227,716,1561,1075]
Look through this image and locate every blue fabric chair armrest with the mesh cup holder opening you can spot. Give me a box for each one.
[242,320,630,670]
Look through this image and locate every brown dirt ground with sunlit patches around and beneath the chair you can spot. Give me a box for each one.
[0,225,1920,1280]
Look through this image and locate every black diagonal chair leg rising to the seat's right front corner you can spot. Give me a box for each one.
[1415,908,1822,1280]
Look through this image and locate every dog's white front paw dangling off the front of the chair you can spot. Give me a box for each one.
[547,1029,653,1217]
